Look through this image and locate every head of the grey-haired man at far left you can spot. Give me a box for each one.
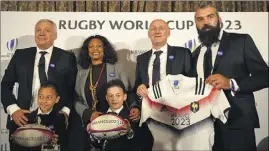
[35,21,57,50]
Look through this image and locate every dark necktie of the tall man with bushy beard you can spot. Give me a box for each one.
[204,46,212,79]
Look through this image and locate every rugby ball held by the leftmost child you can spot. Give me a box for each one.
[11,124,54,147]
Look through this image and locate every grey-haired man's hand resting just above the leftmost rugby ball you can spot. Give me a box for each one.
[11,109,31,127]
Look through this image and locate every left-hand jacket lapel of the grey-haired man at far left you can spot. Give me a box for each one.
[26,47,37,92]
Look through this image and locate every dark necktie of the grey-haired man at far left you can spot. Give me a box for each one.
[38,51,47,85]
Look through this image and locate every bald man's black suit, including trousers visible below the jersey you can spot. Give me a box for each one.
[134,45,192,151]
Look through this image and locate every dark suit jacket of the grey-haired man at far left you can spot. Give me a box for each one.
[1,47,77,114]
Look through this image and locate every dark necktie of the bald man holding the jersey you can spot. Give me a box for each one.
[152,51,163,85]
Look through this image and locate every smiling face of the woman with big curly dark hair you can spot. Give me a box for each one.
[88,38,104,62]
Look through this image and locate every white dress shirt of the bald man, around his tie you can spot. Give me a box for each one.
[148,44,168,87]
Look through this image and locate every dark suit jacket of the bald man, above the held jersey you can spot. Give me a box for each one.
[134,45,192,92]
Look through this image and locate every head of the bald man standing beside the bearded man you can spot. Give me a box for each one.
[148,19,170,48]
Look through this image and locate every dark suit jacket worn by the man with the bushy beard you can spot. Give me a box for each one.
[193,31,268,128]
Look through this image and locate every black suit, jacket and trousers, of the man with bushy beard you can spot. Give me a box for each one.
[193,32,268,150]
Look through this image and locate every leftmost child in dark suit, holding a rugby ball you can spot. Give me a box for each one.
[7,82,67,151]
